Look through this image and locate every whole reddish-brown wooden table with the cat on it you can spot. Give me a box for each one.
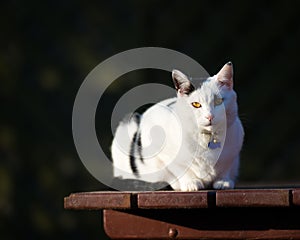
[64,188,300,239]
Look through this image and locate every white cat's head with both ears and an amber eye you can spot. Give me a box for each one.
[172,62,237,131]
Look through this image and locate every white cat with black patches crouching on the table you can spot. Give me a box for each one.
[111,62,244,191]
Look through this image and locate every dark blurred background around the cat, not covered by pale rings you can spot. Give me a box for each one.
[0,0,300,239]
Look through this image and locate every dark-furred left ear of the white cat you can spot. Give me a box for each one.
[172,70,195,96]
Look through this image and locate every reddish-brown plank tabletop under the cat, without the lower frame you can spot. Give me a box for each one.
[64,188,300,210]
